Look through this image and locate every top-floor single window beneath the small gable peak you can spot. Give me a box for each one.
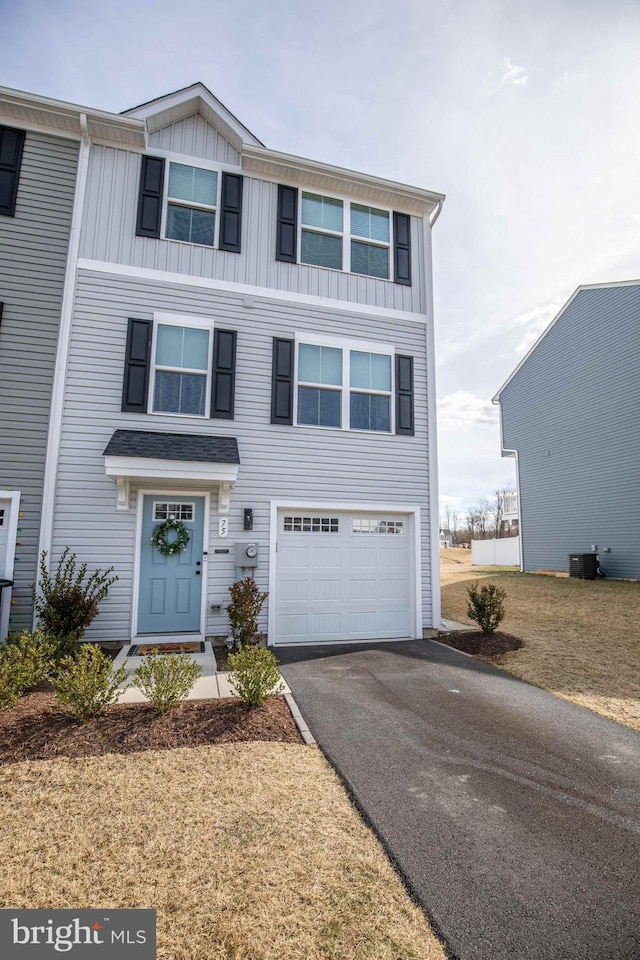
[165,162,219,247]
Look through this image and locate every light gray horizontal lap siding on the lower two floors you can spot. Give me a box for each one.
[53,271,431,640]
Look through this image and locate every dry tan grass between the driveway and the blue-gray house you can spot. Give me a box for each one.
[441,548,640,730]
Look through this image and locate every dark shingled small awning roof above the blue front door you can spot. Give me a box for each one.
[104,430,240,463]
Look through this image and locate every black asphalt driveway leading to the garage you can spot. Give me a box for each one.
[277,641,640,960]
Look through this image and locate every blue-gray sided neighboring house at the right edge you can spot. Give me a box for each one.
[494,281,640,579]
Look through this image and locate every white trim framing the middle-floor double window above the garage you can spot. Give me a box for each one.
[293,332,396,437]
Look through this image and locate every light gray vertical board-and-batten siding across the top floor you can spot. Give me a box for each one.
[80,141,431,313]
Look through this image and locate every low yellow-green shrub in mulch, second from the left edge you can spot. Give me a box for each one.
[51,643,127,720]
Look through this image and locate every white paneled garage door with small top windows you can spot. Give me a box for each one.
[275,510,414,643]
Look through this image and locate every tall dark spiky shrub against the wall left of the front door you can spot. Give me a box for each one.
[33,547,118,658]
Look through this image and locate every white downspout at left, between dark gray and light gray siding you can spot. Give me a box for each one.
[34,113,91,600]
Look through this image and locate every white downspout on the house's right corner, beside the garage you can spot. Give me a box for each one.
[422,212,443,630]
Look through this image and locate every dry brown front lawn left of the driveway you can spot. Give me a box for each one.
[0,743,445,960]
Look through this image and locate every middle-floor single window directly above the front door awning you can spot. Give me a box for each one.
[151,318,213,417]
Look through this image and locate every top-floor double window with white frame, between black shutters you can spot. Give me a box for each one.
[300,190,391,280]
